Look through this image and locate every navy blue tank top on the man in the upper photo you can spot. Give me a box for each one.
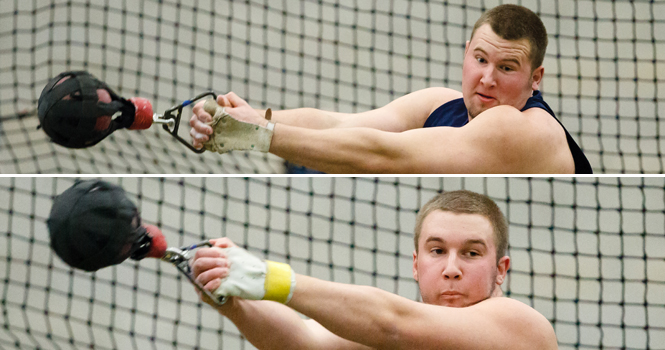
[423,90,593,174]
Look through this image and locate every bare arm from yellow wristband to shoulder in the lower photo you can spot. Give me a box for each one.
[288,275,557,349]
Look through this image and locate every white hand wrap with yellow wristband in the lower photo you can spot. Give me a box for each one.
[213,247,296,304]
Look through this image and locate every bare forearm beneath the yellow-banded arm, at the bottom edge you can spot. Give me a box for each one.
[219,298,315,349]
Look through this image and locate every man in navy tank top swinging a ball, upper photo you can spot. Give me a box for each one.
[190,4,591,174]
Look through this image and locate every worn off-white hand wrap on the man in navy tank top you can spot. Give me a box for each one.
[203,100,275,153]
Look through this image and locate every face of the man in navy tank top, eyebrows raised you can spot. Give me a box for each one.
[462,24,544,118]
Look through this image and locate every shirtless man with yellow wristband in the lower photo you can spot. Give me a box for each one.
[192,191,557,349]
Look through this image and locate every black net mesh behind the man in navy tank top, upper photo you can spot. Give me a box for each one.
[0,0,665,173]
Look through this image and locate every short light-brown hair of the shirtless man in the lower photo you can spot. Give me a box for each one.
[413,190,508,262]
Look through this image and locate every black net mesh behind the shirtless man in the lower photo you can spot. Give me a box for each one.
[0,178,665,349]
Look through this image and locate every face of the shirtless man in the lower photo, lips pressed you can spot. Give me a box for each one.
[413,210,510,307]
